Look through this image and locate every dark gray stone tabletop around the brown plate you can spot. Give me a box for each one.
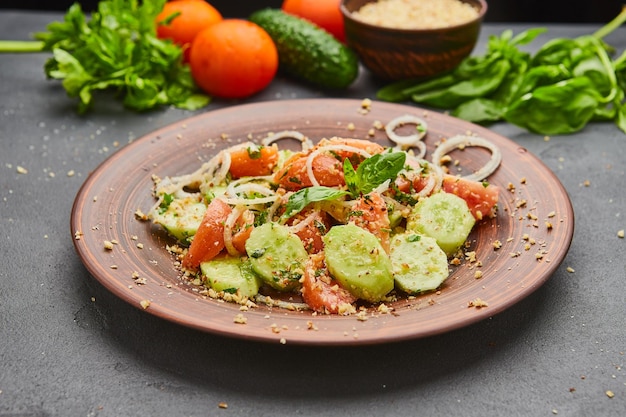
[0,12,626,417]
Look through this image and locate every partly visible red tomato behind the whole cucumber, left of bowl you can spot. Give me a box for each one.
[281,0,346,43]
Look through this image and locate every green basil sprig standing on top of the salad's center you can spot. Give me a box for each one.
[343,152,406,197]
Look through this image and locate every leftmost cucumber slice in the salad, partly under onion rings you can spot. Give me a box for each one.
[153,197,206,245]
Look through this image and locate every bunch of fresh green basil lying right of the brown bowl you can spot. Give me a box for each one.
[377,6,626,135]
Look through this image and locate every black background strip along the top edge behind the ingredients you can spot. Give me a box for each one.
[0,0,624,22]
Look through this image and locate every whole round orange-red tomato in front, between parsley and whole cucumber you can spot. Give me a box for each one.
[189,19,278,98]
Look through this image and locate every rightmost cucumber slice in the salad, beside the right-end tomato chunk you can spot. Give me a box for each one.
[406,191,476,256]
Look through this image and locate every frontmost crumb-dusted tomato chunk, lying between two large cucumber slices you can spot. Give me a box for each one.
[302,252,356,314]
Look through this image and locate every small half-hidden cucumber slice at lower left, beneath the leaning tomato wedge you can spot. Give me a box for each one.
[200,255,260,297]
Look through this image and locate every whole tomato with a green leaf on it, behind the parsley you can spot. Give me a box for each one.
[156,0,223,62]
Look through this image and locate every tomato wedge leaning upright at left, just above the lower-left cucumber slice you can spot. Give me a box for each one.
[183,198,232,270]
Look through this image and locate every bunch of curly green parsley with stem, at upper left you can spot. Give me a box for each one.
[0,0,210,113]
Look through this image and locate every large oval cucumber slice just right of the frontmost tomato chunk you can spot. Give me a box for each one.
[323,223,393,302]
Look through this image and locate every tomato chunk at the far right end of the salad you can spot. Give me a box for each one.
[442,175,500,221]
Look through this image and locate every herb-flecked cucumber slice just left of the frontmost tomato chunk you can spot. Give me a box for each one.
[246,223,309,291]
